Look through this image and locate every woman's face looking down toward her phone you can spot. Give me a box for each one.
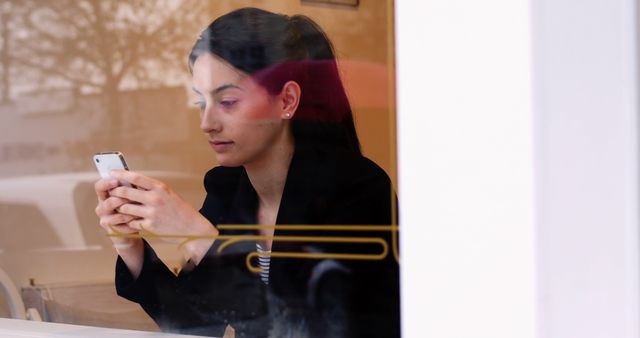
[192,54,288,167]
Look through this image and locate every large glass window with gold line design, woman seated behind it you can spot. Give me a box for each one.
[0,0,399,337]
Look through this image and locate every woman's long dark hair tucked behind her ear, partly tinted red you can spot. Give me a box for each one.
[189,8,361,154]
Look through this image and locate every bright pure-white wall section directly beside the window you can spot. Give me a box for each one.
[396,0,535,338]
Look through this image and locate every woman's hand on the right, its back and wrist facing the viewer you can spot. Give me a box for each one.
[109,170,218,264]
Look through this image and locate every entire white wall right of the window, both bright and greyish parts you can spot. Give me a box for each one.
[396,0,640,338]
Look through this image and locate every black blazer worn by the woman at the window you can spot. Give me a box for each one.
[116,147,400,337]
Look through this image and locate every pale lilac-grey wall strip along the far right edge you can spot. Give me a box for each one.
[532,0,640,338]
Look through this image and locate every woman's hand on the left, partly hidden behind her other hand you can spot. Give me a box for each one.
[94,178,144,278]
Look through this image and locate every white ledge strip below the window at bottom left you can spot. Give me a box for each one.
[0,318,218,338]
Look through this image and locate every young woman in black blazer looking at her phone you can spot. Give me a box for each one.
[95,8,400,337]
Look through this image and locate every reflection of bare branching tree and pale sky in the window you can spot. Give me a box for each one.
[0,0,207,144]
